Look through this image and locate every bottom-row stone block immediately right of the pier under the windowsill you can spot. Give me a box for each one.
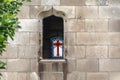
[67,71,86,80]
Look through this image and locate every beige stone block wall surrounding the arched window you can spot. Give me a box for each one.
[0,0,120,80]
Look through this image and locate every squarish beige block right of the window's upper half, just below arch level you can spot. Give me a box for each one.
[67,19,84,32]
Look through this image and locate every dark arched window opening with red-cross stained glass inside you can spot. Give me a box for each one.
[42,15,64,59]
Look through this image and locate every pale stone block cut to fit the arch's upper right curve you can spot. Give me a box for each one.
[53,6,75,18]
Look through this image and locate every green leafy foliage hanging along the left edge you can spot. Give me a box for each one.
[0,0,30,79]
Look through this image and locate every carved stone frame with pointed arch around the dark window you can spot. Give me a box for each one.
[38,7,66,60]
